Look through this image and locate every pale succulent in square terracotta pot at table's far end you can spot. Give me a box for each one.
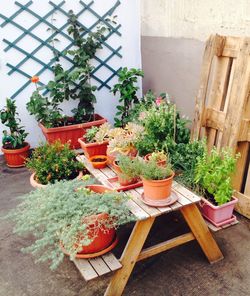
[84,122,111,143]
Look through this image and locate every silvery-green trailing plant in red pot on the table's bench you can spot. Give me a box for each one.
[8,179,134,269]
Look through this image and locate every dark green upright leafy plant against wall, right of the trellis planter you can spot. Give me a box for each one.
[111,67,144,127]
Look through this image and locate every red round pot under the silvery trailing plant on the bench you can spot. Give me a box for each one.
[75,185,116,254]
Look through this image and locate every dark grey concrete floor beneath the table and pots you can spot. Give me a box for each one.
[0,159,250,296]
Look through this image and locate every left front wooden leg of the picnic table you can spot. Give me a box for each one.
[104,217,155,296]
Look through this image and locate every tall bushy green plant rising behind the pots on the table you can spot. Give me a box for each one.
[136,103,190,155]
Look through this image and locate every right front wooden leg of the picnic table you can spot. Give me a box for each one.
[181,204,223,263]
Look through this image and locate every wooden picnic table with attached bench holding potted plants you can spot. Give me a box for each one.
[74,155,223,296]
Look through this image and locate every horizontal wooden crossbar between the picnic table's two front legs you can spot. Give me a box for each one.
[137,232,195,261]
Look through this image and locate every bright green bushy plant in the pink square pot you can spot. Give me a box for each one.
[195,148,239,205]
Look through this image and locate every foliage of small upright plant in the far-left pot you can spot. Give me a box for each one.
[0,98,28,149]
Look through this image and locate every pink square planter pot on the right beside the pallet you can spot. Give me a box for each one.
[199,197,238,227]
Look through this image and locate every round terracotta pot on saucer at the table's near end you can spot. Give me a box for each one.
[141,173,174,200]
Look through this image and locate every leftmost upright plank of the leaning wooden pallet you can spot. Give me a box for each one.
[192,35,225,140]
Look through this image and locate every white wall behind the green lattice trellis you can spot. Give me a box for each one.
[0,0,141,146]
